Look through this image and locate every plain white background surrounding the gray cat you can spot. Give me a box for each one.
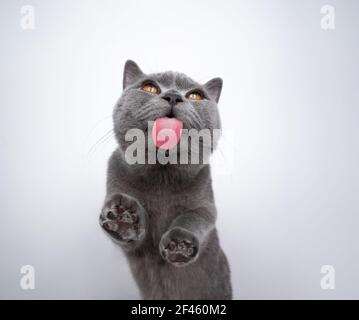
[0,0,359,299]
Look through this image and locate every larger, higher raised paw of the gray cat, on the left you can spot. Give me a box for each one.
[100,193,146,244]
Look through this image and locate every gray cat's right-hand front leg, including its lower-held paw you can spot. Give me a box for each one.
[159,210,215,267]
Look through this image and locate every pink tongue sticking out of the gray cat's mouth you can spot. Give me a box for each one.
[152,118,183,150]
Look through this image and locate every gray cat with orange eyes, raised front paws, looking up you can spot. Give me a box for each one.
[100,61,232,299]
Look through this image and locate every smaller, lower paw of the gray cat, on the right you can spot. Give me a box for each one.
[160,227,199,267]
